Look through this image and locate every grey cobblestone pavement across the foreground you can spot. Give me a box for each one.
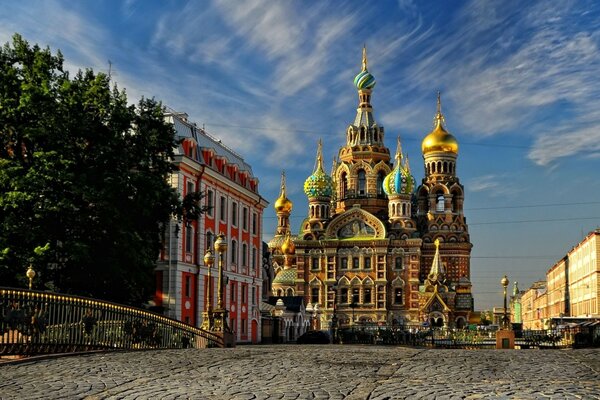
[0,345,600,400]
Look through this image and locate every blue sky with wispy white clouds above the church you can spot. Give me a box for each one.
[0,0,600,310]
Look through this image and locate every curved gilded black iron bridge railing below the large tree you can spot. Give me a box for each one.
[0,287,223,356]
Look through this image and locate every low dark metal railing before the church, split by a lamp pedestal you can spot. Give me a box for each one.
[338,326,599,349]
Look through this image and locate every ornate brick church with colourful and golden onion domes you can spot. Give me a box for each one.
[268,48,473,329]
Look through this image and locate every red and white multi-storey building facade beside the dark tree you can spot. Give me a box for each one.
[154,112,268,343]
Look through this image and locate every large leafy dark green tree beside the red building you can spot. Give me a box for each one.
[0,35,183,304]
